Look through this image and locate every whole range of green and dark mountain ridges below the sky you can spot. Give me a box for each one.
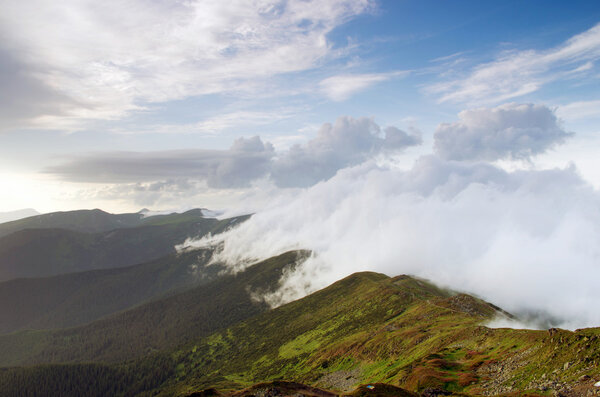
[0,210,600,396]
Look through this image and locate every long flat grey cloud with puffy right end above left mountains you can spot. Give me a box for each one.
[45,117,421,188]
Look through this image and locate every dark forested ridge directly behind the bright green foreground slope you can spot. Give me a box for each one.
[0,252,300,366]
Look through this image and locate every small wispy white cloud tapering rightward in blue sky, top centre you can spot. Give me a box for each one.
[319,72,407,101]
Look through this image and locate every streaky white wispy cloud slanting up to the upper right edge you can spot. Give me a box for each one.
[426,24,600,104]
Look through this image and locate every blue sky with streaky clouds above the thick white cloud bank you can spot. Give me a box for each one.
[0,0,600,211]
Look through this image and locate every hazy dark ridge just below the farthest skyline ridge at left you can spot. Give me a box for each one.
[0,210,247,281]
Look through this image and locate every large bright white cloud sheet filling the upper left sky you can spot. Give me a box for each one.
[0,0,374,128]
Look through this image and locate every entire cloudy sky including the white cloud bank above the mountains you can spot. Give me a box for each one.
[0,0,600,329]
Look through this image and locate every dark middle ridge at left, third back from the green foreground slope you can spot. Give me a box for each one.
[0,250,223,334]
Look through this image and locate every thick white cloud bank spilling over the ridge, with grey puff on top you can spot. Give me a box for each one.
[184,105,600,328]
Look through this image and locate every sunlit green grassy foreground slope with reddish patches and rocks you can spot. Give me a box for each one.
[0,268,600,396]
